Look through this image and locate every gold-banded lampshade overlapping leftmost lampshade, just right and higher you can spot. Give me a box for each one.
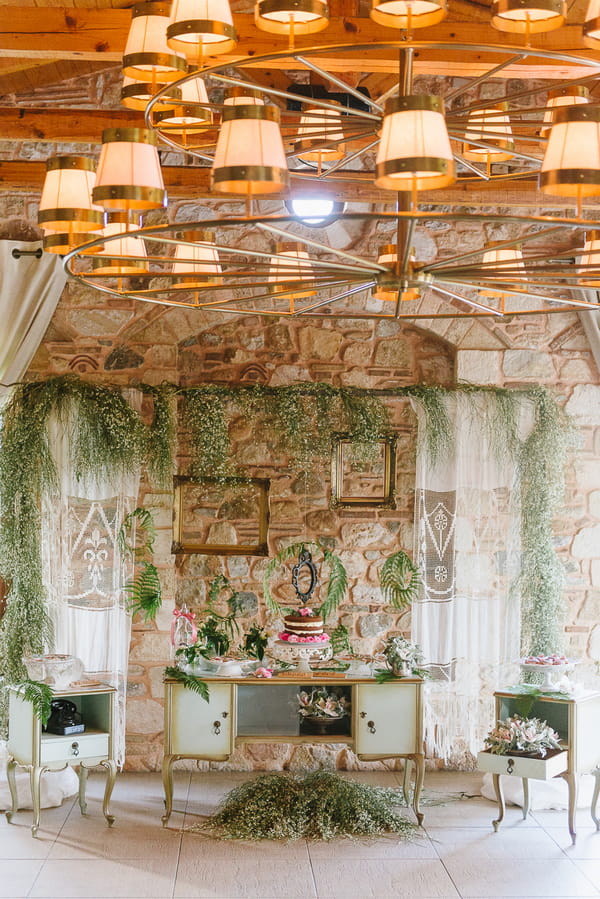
[92,128,167,210]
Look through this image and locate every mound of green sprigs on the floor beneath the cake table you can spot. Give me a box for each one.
[188,771,418,840]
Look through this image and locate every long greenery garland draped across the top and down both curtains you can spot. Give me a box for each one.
[0,375,571,704]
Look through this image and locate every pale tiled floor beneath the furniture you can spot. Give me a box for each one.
[0,772,600,899]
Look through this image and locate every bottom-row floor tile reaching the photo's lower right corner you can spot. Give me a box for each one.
[443,856,598,899]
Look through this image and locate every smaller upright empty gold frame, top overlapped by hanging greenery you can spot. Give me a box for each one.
[329,434,396,509]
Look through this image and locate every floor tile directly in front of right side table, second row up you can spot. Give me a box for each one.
[427,827,565,862]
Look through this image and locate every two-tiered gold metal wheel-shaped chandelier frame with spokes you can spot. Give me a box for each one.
[65,40,600,320]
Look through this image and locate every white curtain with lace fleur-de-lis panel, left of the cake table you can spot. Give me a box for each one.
[42,400,140,765]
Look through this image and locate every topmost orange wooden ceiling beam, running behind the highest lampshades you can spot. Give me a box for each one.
[0,6,600,77]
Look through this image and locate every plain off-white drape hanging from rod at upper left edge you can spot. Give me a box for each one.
[0,240,67,396]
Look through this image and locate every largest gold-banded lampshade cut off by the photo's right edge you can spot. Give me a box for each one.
[539,103,600,198]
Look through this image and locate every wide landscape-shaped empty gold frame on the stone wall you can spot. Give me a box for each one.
[171,475,270,556]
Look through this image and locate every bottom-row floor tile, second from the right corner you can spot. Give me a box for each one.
[313,858,459,899]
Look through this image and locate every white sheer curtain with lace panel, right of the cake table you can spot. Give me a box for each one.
[412,392,520,765]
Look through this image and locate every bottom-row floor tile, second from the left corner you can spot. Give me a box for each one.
[29,859,175,899]
